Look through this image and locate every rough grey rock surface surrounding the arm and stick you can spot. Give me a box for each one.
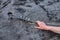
[0,0,60,40]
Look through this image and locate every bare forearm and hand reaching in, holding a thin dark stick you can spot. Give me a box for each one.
[35,21,60,34]
